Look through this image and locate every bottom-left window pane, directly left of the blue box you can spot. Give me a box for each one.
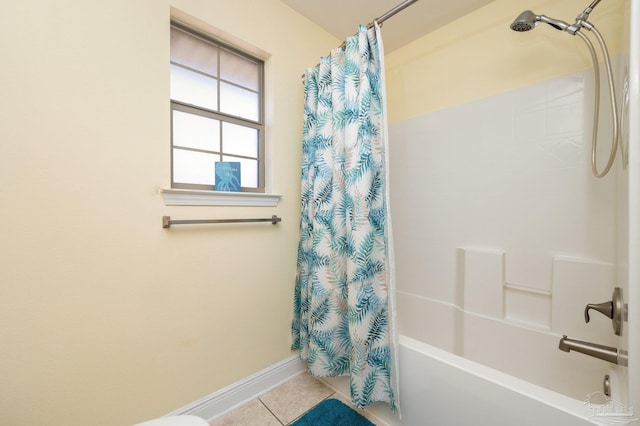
[173,149,220,186]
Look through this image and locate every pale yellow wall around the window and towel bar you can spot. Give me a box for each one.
[0,0,339,425]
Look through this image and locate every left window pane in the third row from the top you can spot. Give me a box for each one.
[172,111,220,152]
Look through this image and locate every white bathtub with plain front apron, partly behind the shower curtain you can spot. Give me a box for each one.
[326,335,593,426]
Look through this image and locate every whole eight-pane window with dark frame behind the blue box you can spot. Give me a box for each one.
[171,24,265,192]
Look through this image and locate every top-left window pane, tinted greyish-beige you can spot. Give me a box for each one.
[171,28,218,77]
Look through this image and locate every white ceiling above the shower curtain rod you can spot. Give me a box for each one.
[280,0,493,53]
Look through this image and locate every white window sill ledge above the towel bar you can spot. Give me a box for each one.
[160,188,282,207]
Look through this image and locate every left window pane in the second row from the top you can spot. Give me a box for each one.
[171,64,218,110]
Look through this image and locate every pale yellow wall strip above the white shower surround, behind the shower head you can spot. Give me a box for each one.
[385,0,624,122]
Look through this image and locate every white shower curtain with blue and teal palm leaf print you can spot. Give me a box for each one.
[292,24,399,413]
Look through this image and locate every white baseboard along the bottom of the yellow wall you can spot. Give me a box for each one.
[167,355,307,422]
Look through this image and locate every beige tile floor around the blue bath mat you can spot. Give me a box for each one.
[210,373,384,426]
